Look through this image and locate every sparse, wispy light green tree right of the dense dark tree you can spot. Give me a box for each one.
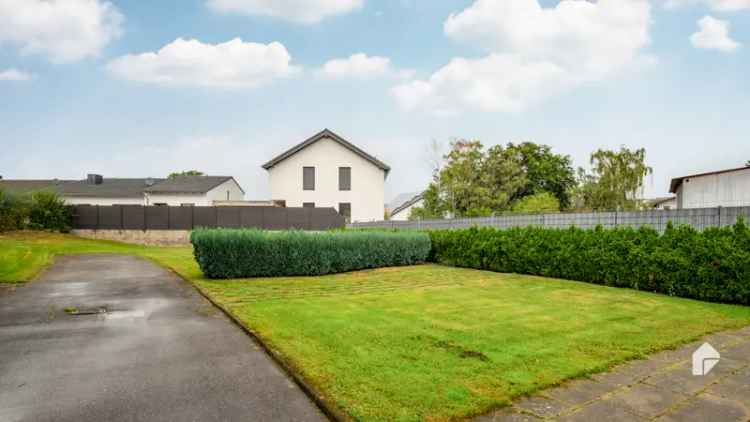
[576,146,653,211]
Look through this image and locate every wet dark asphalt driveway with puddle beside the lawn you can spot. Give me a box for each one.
[0,255,325,422]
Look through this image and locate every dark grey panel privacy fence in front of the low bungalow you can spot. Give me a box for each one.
[73,205,345,230]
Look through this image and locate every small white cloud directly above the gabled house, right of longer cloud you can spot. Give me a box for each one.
[318,53,414,79]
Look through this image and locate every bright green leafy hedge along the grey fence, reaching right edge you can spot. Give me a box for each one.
[429,221,750,305]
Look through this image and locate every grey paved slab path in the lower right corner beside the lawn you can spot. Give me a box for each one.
[477,327,750,422]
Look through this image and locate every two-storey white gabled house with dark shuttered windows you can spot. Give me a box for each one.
[263,129,390,221]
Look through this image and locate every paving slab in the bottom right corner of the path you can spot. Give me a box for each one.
[657,394,750,422]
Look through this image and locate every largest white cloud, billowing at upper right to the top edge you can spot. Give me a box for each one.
[392,0,652,113]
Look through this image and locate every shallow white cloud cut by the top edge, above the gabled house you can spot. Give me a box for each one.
[207,0,364,24]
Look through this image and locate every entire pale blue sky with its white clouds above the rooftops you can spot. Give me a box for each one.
[0,0,750,199]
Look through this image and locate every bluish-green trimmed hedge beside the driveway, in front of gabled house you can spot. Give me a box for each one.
[190,229,430,278]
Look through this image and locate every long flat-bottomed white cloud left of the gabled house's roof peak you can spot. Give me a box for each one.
[107,38,299,89]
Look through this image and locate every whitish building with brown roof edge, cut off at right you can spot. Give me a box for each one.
[669,167,750,209]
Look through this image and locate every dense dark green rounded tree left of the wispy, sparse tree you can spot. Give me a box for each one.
[505,142,576,209]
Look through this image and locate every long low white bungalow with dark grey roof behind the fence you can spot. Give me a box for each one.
[0,174,245,206]
